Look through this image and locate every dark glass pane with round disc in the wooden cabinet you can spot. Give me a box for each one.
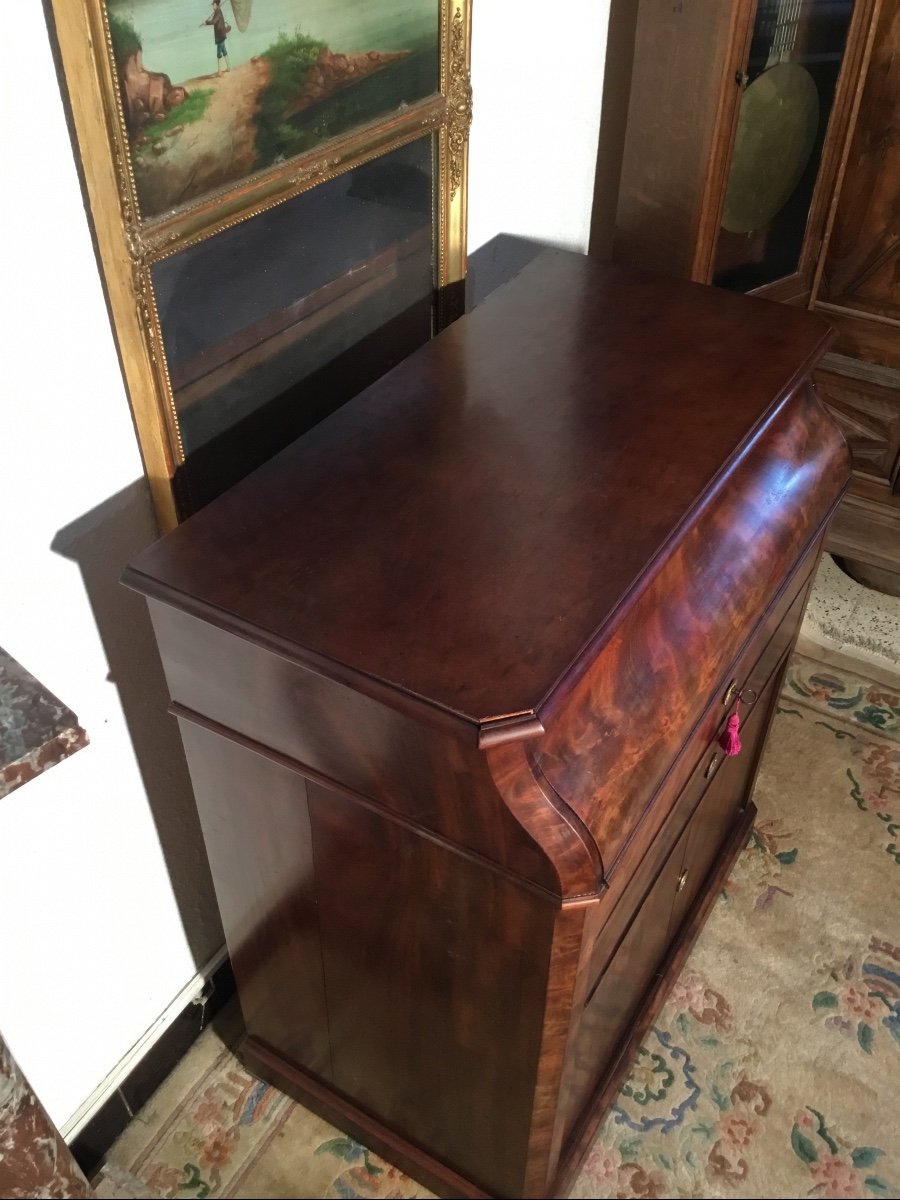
[714,0,853,292]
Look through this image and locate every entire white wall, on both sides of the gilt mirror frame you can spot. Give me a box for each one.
[0,0,607,1126]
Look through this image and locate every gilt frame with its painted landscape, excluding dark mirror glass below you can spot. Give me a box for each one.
[50,0,472,530]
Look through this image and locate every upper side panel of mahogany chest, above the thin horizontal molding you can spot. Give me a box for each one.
[150,600,566,890]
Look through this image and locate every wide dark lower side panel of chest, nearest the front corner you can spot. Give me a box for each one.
[308,782,558,1195]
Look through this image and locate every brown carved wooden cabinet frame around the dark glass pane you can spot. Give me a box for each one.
[600,0,900,593]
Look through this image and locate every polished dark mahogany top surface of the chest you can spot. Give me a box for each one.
[125,251,830,724]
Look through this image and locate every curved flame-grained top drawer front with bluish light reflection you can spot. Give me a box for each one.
[538,388,847,871]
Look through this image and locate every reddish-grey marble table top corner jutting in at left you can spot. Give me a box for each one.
[0,647,88,797]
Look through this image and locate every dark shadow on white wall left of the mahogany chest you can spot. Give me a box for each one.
[50,479,224,966]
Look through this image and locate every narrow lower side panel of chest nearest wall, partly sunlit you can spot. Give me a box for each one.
[179,720,331,1080]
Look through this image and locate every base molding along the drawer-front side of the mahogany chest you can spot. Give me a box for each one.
[552,802,756,1195]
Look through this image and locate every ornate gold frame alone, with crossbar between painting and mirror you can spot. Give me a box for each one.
[50,0,472,532]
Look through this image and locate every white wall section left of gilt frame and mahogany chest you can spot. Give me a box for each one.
[0,4,221,1126]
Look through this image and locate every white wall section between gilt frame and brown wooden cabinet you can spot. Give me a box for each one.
[469,0,610,252]
